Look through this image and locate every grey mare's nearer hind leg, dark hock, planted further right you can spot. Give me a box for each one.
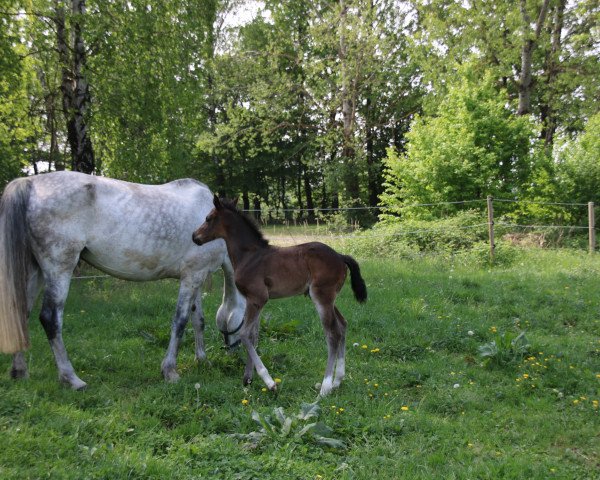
[40,270,87,390]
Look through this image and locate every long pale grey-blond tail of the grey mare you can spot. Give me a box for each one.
[0,179,33,353]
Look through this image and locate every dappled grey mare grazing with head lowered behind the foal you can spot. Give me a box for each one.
[0,171,245,389]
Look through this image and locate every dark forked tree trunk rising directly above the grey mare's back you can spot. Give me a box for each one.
[55,0,96,173]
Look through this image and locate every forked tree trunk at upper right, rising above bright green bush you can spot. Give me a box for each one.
[517,0,550,115]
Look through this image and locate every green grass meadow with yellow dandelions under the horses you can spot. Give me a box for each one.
[0,251,600,479]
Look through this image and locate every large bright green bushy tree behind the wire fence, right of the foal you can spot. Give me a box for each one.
[381,68,534,215]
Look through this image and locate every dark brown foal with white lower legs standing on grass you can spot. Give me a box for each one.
[193,195,367,395]
